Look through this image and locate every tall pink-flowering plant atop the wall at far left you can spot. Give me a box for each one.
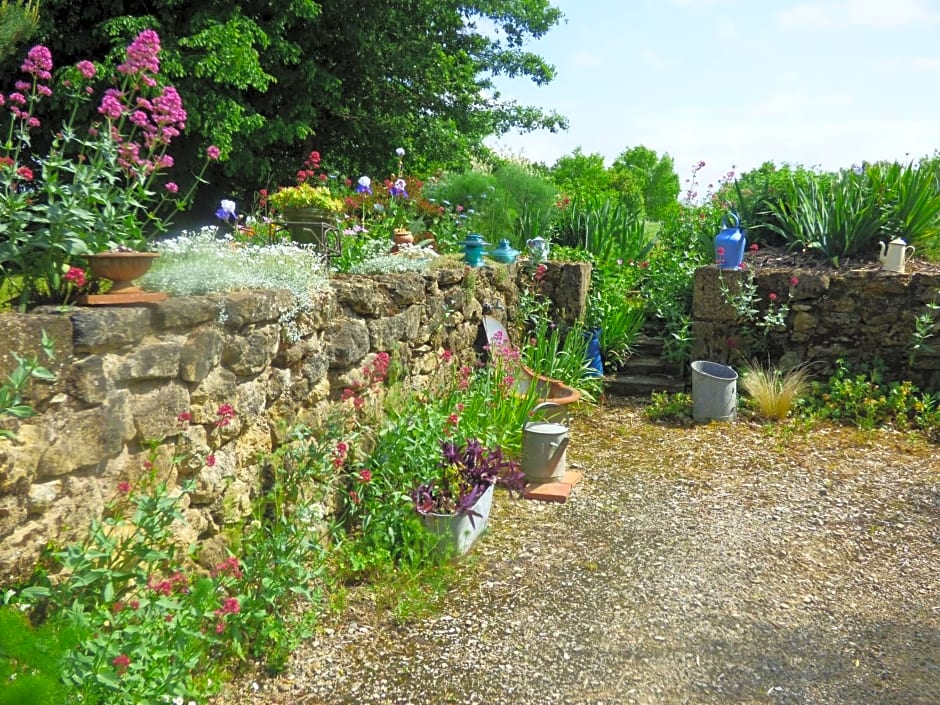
[0,30,221,308]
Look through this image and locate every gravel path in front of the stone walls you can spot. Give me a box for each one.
[216,401,940,705]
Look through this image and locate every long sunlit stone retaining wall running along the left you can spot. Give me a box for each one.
[0,263,590,584]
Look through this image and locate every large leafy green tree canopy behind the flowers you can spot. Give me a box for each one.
[9,0,567,197]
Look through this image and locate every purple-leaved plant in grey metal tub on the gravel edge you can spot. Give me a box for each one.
[411,438,525,555]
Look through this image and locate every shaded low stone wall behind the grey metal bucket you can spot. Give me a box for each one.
[692,267,940,391]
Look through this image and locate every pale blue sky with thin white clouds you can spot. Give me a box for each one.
[488,0,940,192]
